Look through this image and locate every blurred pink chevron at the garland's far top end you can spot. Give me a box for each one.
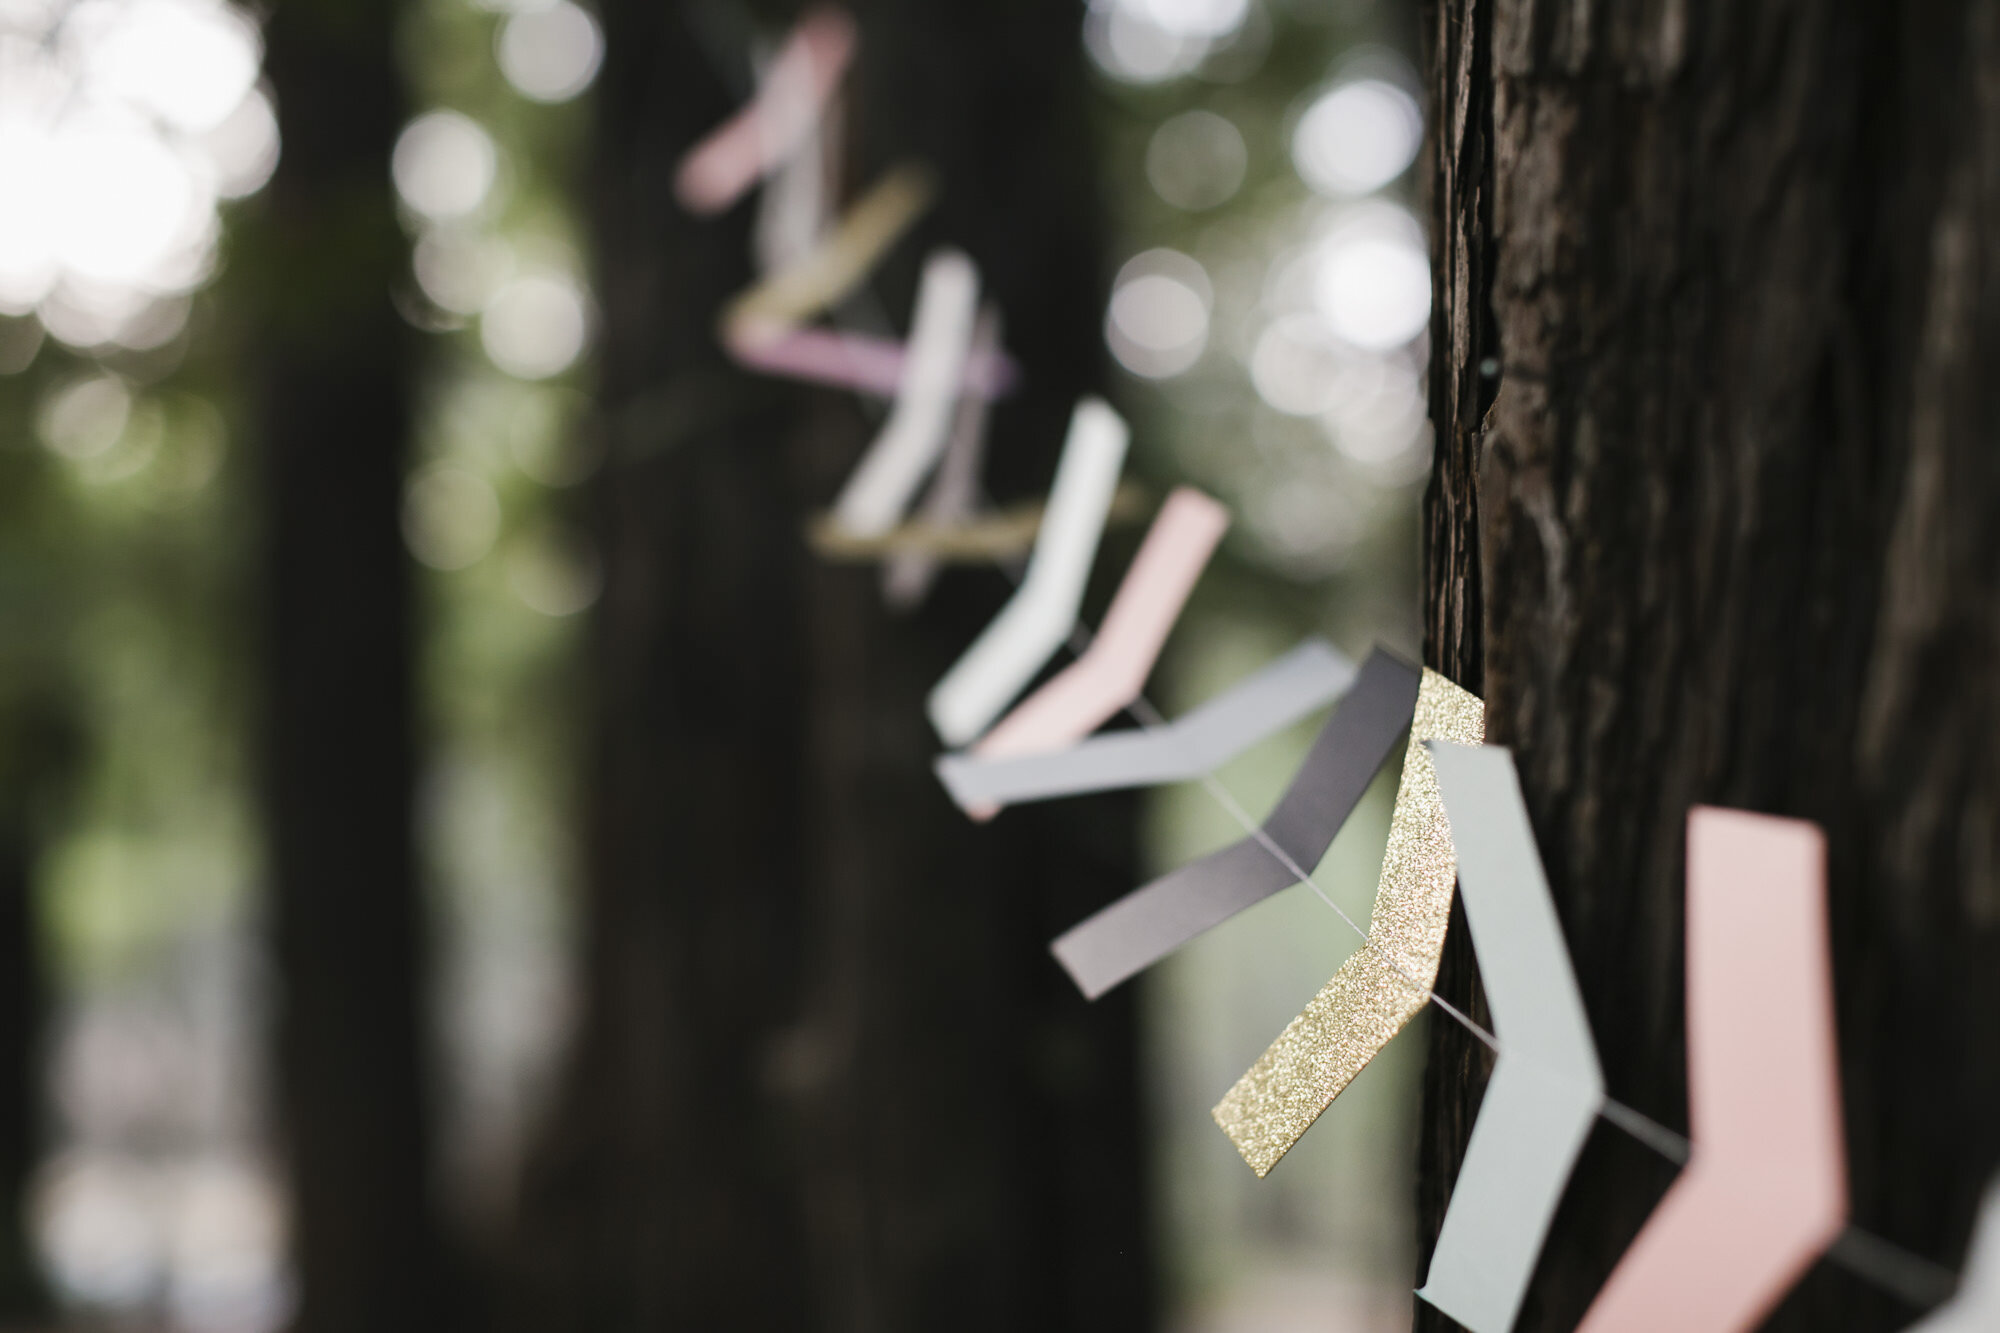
[674,6,856,214]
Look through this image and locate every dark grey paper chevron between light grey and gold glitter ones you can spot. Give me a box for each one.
[1050,648,1418,999]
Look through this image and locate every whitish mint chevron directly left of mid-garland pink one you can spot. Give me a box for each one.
[928,398,1132,745]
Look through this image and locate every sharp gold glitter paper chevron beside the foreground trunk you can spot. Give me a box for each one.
[1212,669,1486,1175]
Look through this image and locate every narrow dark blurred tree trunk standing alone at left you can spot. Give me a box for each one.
[248,0,446,1333]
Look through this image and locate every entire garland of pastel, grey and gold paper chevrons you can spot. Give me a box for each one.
[676,10,1968,1304]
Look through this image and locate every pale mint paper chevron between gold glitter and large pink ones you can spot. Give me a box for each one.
[1416,741,1604,1333]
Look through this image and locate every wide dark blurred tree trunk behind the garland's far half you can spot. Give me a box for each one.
[510,0,1150,1333]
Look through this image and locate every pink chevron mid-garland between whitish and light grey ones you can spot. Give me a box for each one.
[966,486,1230,821]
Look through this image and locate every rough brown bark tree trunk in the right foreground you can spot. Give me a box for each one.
[1418,0,2000,1329]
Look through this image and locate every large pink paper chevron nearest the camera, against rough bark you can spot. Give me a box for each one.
[1578,807,1848,1333]
